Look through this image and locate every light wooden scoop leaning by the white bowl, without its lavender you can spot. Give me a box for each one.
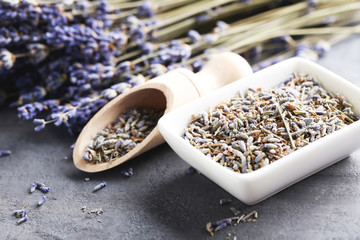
[73,52,252,172]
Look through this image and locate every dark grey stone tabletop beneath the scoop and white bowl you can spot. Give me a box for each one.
[0,36,360,239]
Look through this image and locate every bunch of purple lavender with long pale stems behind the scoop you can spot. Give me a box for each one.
[0,0,360,135]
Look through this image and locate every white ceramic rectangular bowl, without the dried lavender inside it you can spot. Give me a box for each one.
[158,58,360,204]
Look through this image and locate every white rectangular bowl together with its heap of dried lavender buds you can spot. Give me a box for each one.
[158,58,360,204]
